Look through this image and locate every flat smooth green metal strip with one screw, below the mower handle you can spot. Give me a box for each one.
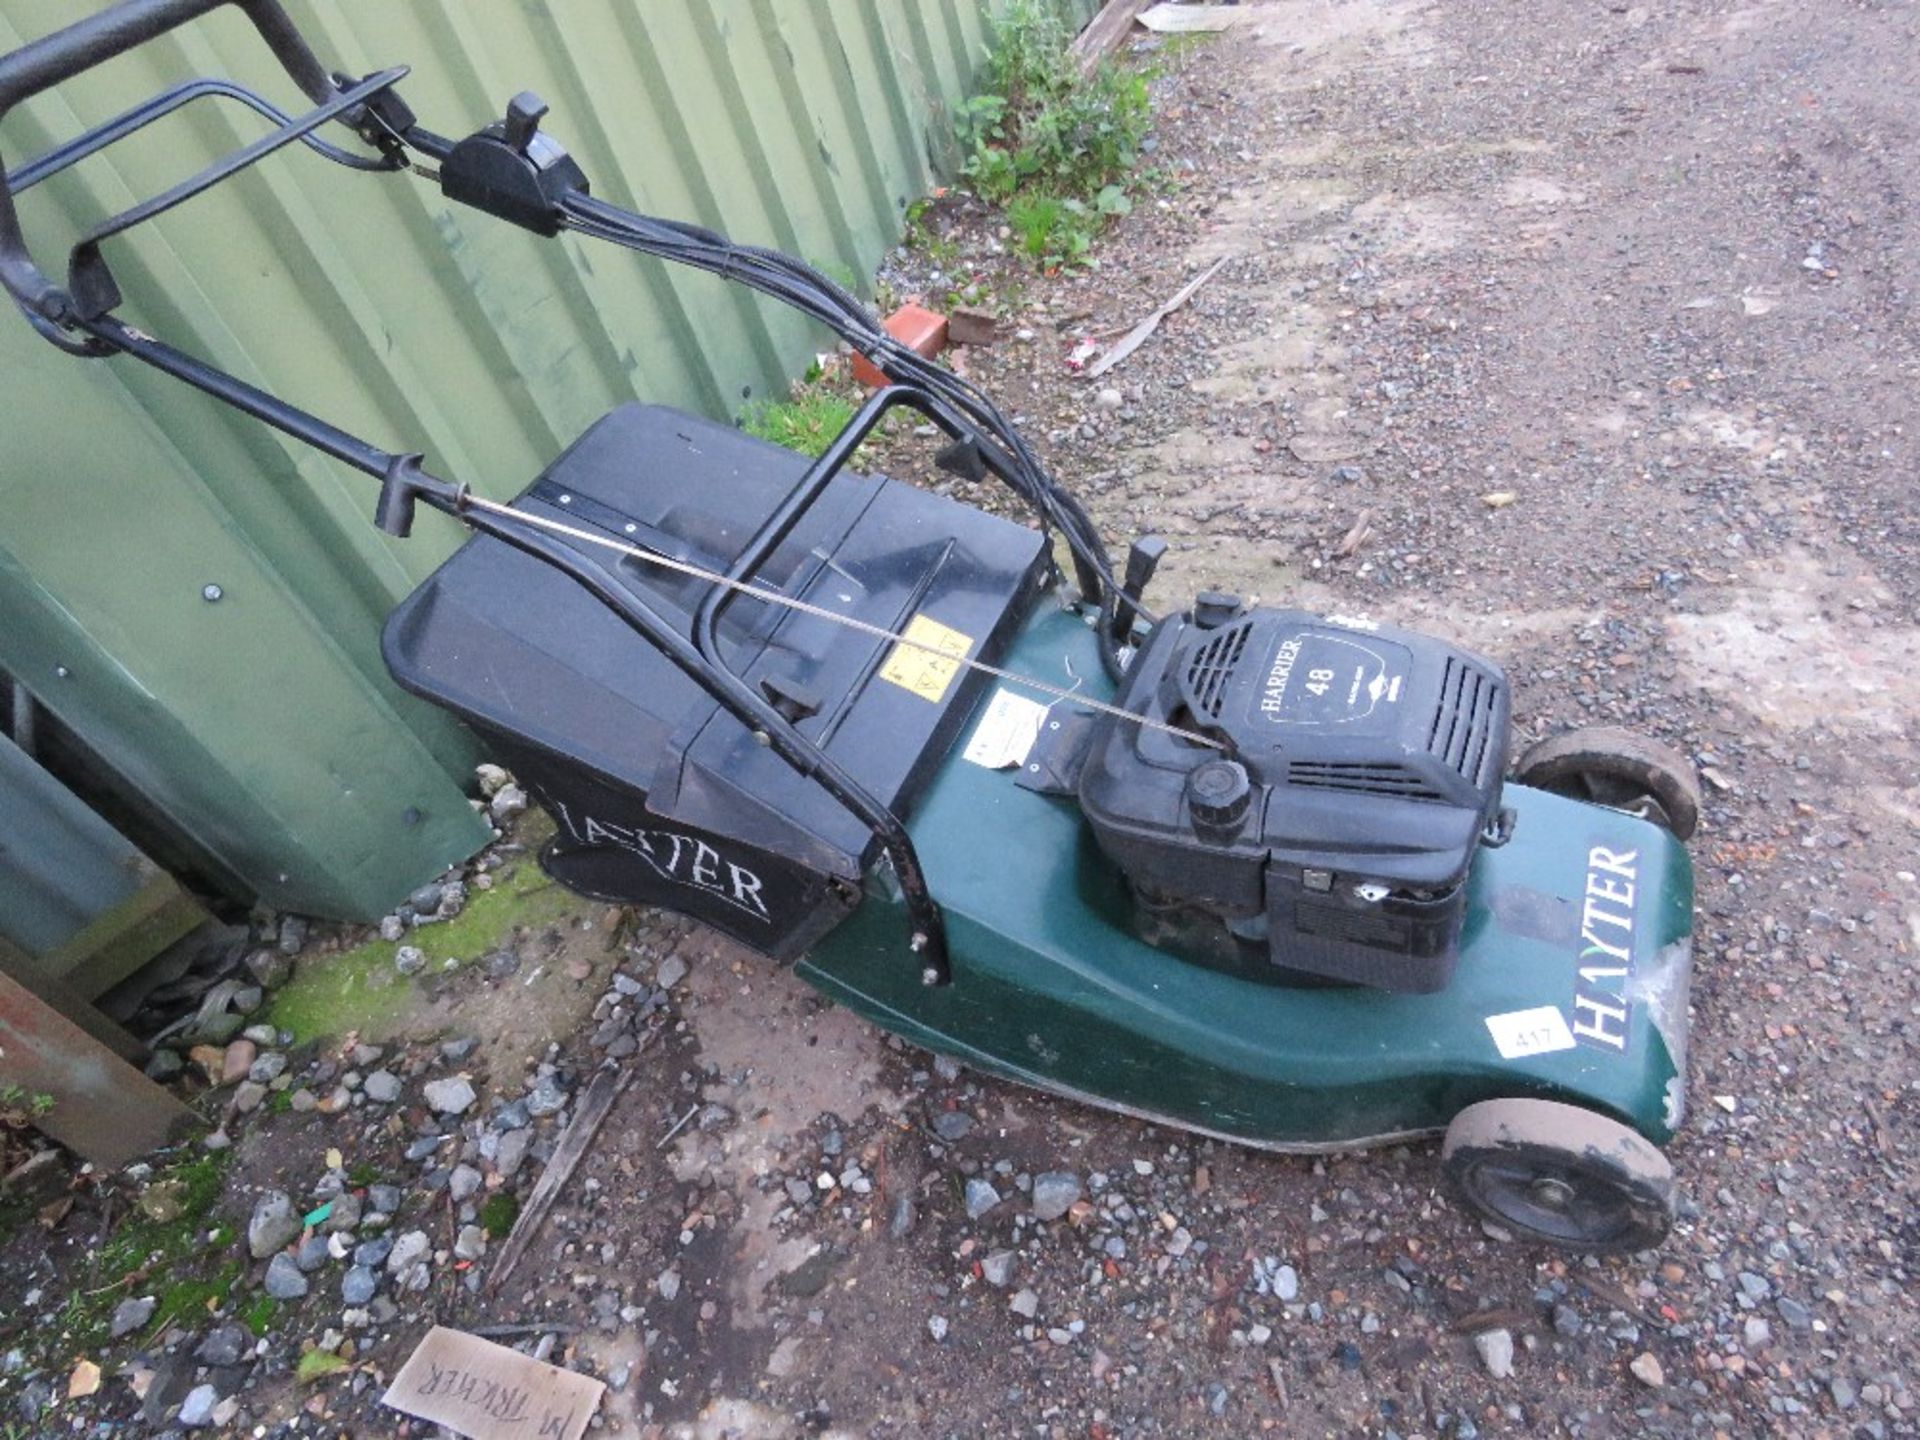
[0,343,484,916]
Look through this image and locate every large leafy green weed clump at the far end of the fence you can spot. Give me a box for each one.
[960,0,1152,269]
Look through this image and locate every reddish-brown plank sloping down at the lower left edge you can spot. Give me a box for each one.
[0,975,196,1169]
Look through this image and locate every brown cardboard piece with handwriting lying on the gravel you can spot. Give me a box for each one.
[380,1325,607,1440]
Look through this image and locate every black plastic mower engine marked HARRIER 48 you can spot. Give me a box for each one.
[1079,597,1509,991]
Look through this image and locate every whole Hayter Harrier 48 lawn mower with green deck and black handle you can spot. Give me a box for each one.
[0,0,1699,1252]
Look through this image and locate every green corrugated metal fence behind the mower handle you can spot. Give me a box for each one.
[0,0,1036,916]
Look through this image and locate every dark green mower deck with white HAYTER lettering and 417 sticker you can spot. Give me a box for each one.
[799,605,1693,1150]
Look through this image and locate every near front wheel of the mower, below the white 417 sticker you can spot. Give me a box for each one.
[1440,1100,1674,1254]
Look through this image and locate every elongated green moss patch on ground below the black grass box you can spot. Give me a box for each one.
[265,844,588,1044]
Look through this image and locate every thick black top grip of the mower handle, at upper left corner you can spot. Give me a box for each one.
[0,0,336,338]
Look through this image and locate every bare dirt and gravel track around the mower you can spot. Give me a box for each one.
[15,0,1920,1440]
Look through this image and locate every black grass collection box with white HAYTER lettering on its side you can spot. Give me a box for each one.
[382,405,1048,960]
